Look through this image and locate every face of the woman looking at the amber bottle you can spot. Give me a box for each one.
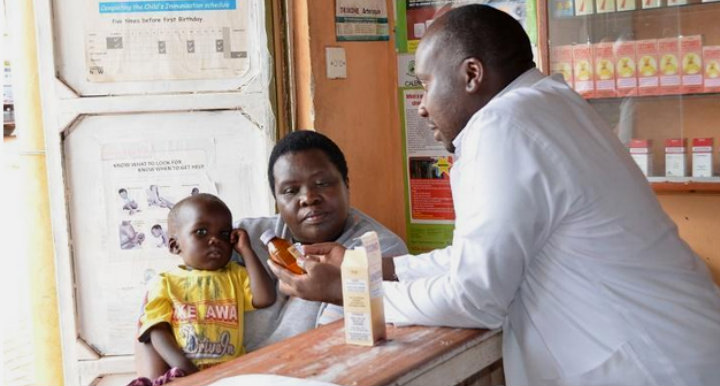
[273,149,350,244]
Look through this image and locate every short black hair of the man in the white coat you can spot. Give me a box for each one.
[428,4,535,76]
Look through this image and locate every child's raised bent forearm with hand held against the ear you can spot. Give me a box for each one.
[231,229,275,308]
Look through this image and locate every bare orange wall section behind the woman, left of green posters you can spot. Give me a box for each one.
[308,0,405,238]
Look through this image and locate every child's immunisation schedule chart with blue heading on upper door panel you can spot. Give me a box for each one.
[84,0,249,82]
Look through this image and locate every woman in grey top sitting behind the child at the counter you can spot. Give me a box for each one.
[136,131,407,378]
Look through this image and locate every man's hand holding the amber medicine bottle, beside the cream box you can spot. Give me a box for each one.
[268,243,345,305]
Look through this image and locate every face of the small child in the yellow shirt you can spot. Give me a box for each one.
[171,201,232,271]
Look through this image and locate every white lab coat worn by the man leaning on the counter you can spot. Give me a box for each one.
[384,69,720,385]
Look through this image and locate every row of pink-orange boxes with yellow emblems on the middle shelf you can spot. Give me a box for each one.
[550,35,720,99]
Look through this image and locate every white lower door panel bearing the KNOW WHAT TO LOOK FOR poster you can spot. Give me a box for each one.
[64,111,273,356]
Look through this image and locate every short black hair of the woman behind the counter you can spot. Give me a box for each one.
[268,130,350,196]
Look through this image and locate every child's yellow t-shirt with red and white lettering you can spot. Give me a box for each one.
[138,262,253,368]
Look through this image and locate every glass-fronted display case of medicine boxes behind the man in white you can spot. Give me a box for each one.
[538,0,720,193]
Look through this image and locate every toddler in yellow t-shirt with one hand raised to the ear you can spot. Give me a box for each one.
[130,193,275,385]
